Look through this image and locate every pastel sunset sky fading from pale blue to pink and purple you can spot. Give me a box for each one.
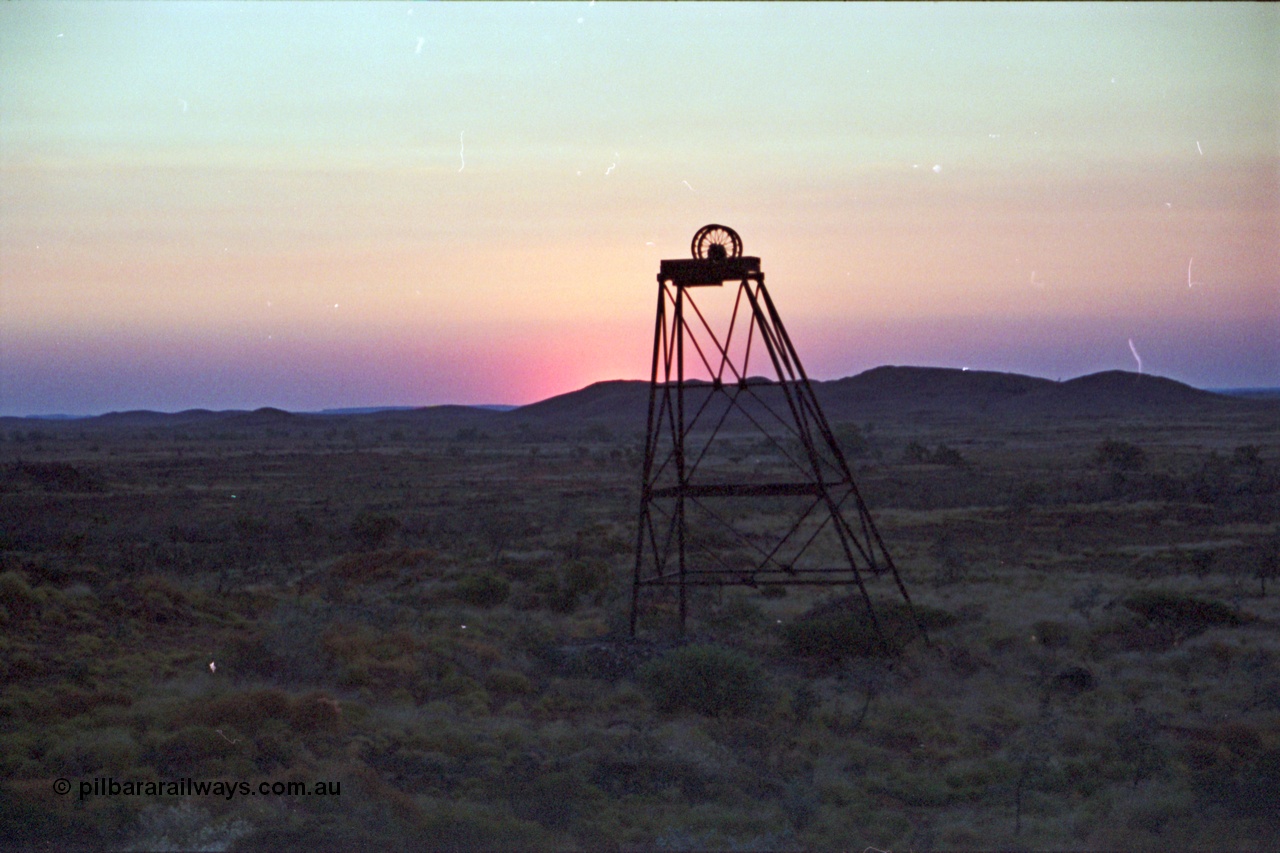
[0,1,1280,415]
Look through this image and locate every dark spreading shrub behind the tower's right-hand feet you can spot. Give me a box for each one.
[782,597,955,660]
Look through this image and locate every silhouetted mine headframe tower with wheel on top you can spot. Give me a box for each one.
[631,225,923,640]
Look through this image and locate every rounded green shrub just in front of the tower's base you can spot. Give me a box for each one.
[636,646,764,716]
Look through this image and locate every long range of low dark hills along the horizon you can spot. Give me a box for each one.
[0,366,1280,435]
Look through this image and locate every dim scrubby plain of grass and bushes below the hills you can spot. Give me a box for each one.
[0,399,1280,850]
